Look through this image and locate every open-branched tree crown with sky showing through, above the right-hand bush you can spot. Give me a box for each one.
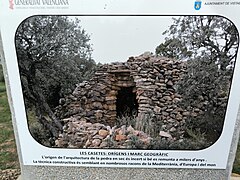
[156,16,238,71]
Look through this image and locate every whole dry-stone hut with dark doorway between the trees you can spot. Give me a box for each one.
[56,54,189,146]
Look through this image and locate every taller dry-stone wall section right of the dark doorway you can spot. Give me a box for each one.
[128,55,190,137]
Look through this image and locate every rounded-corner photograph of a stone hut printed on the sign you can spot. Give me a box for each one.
[15,15,239,150]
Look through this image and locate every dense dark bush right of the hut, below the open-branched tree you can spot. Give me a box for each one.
[176,58,231,143]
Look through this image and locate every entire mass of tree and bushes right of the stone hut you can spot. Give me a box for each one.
[156,16,239,145]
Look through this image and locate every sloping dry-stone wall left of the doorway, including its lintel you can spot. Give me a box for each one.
[56,63,134,126]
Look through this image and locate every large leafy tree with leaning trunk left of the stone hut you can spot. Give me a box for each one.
[15,16,95,141]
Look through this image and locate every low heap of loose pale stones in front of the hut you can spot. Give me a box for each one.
[55,118,151,149]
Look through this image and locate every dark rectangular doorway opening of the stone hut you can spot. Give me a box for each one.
[116,87,138,117]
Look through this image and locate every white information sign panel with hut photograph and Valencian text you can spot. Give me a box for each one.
[0,0,240,169]
